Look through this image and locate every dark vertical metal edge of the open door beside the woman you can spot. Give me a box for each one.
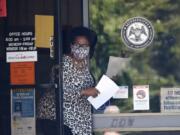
[54,0,64,135]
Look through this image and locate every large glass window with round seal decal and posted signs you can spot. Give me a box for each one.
[89,0,180,134]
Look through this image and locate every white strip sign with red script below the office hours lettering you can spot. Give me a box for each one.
[6,51,37,62]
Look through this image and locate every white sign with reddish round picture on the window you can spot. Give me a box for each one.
[133,85,149,110]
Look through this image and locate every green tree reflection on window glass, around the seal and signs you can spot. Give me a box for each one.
[89,0,180,113]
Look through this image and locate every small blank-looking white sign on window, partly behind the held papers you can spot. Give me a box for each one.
[113,86,128,99]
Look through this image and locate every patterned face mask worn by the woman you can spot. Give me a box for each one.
[71,44,90,60]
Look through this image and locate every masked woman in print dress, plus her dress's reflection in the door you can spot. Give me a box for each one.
[38,27,99,135]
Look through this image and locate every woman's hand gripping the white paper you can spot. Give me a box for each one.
[81,88,99,97]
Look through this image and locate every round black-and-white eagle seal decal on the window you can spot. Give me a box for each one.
[121,17,154,50]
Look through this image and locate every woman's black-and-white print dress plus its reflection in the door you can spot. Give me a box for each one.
[38,55,94,135]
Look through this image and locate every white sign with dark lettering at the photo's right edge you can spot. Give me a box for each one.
[161,88,180,113]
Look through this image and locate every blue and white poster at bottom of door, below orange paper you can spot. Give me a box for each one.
[11,89,36,135]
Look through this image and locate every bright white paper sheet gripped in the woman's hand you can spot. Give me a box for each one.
[88,75,119,109]
